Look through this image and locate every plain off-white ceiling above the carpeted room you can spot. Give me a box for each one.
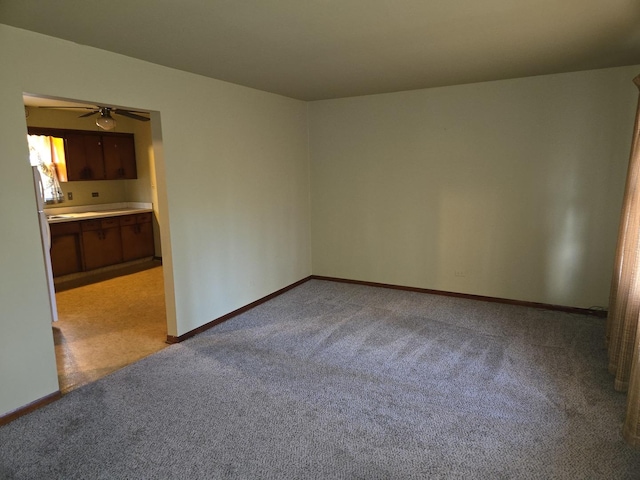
[0,0,640,100]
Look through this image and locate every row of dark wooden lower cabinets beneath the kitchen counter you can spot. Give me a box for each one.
[50,213,155,277]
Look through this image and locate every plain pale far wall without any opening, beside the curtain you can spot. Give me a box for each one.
[309,67,638,308]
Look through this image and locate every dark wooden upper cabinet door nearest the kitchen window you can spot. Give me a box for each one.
[65,133,105,181]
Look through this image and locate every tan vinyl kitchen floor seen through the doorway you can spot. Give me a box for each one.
[53,265,167,393]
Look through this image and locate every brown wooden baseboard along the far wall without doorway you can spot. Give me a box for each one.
[310,275,607,318]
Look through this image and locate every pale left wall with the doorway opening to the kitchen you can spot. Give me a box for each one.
[0,25,311,415]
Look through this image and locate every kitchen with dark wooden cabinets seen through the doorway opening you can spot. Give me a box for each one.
[23,95,166,392]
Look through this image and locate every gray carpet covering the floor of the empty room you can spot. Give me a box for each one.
[0,280,640,479]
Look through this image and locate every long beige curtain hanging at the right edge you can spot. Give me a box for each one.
[607,75,640,447]
